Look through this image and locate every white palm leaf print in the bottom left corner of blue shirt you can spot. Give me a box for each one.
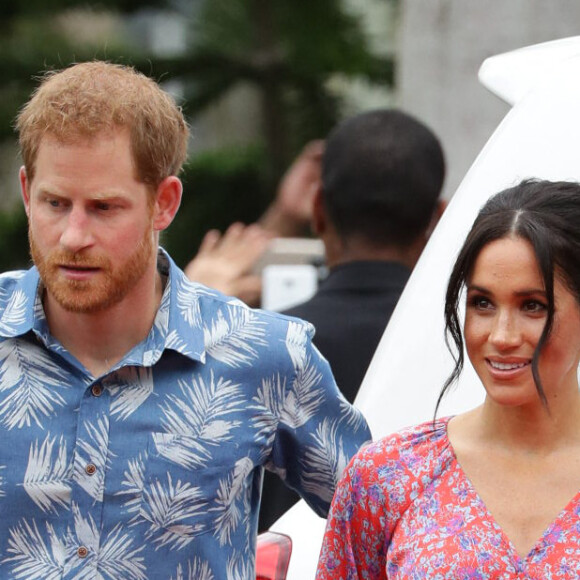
[2,520,66,580]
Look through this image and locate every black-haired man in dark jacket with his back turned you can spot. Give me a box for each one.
[260,109,445,530]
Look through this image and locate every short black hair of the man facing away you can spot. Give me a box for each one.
[322,109,445,246]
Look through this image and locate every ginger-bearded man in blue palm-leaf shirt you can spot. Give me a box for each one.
[0,62,370,580]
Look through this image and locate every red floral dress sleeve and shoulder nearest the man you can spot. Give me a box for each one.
[316,419,453,580]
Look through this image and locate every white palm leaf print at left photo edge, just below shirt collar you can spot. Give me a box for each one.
[0,340,70,429]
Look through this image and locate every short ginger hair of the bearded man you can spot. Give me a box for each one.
[16,61,189,188]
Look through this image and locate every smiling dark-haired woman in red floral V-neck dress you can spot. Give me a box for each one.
[317,180,580,580]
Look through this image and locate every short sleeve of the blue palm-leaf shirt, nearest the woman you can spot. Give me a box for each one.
[269,321,371,517]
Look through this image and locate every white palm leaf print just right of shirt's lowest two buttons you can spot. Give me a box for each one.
[139,473,207,550]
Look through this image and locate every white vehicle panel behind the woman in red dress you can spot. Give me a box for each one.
[271,37,580,580]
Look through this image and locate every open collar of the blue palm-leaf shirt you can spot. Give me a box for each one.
[0,248,205,366]
